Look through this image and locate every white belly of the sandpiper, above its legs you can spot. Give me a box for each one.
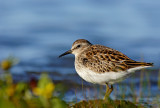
[76,64,133,85]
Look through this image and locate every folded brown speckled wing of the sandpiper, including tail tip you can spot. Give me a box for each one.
[81,45,152,73]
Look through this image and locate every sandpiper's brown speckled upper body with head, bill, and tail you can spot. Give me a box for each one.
[60,39,153,73]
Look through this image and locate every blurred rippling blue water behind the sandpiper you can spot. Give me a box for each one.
[0,0,160,105]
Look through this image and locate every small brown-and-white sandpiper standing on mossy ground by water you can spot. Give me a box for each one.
[59,39,153,100]
